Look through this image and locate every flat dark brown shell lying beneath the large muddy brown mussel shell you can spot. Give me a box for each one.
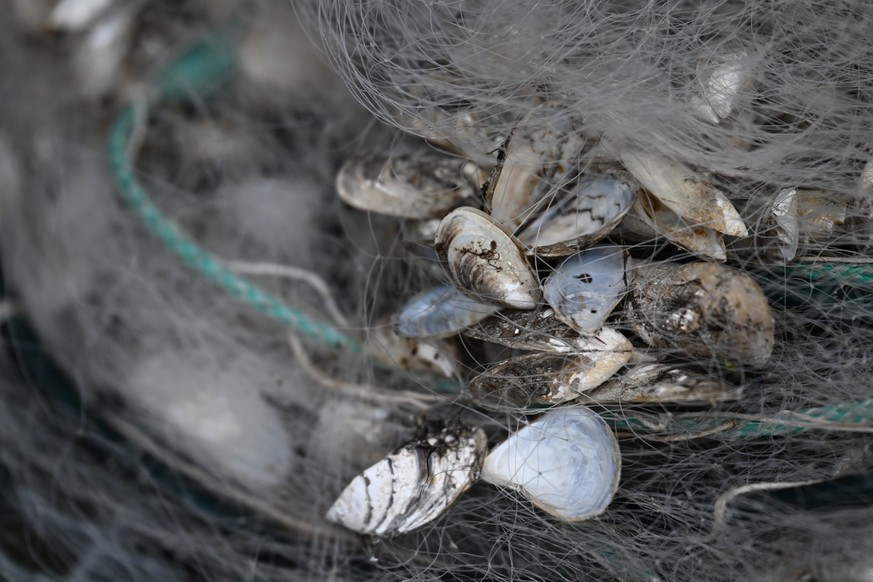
[583,364,741,405]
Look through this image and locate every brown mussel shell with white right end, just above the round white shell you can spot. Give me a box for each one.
[469,328,633,407]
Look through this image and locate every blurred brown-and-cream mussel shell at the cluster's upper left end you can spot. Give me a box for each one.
[336,148,479,219]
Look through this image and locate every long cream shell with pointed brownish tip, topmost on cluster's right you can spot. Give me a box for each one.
[617,149,749,237]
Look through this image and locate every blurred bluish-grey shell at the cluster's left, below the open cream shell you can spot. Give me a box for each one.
[396,285,499,338]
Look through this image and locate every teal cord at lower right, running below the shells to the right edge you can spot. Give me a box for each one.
[604,400,873,438]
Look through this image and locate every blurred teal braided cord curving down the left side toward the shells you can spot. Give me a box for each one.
[109,106,361,352]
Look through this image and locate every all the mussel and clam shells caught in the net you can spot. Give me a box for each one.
[328,57,797,535]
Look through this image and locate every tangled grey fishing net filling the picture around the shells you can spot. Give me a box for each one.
[0,0,873,581]
